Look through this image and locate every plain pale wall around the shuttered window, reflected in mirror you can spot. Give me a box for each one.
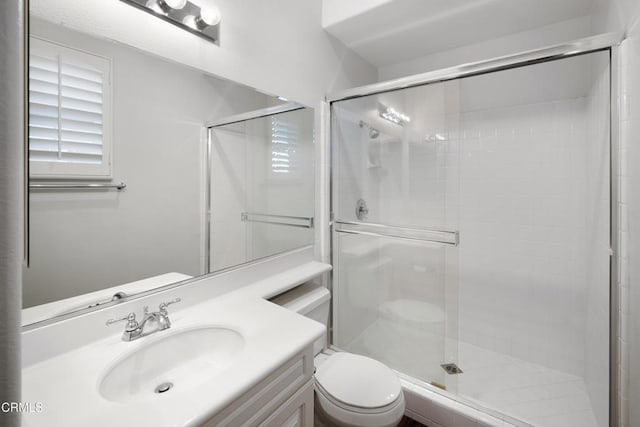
[23,18,268,307]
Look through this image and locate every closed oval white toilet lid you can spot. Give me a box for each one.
[316,352,402,408]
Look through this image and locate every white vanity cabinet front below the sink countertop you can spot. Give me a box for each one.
[202,345,313,427]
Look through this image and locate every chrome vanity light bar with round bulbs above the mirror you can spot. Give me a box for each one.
[120,0,221,45]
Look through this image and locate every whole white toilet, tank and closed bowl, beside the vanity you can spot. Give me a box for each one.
[271,283,405,427]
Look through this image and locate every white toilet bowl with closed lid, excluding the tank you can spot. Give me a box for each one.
[315,352,405,427]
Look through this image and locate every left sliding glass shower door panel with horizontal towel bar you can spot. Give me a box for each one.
[332,80,458,390]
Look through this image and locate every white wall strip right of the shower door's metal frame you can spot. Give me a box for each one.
[593,0,640,427]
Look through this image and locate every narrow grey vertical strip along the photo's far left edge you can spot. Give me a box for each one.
[0,0,24,427]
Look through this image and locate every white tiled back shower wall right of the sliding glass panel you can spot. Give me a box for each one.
[460,98,606,375]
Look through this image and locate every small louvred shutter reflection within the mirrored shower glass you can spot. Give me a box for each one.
[271,115,300,174]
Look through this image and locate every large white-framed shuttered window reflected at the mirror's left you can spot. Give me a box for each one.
[29,37,111,178]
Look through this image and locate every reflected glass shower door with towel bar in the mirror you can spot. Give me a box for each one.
[209,106,314,271]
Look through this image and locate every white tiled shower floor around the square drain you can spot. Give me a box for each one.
[345,322,597,427]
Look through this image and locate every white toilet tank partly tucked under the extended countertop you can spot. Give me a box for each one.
[269,282,331,355]
